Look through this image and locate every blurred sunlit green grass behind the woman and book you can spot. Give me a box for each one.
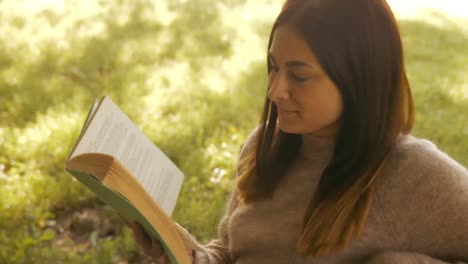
[0,0,468,264]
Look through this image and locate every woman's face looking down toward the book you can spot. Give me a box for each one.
[268,25,343,137]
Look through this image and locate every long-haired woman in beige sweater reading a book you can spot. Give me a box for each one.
[129,0,468,264]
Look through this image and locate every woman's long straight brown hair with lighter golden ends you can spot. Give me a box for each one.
[237,0,414,256]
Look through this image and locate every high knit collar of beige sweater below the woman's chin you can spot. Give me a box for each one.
[299,134,336,162]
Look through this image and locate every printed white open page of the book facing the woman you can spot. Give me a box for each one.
[70,97,184,216]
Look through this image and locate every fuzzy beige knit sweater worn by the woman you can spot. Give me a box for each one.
[186,130,468,264]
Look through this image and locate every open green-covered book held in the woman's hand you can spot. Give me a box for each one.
[66,96,190,264]
